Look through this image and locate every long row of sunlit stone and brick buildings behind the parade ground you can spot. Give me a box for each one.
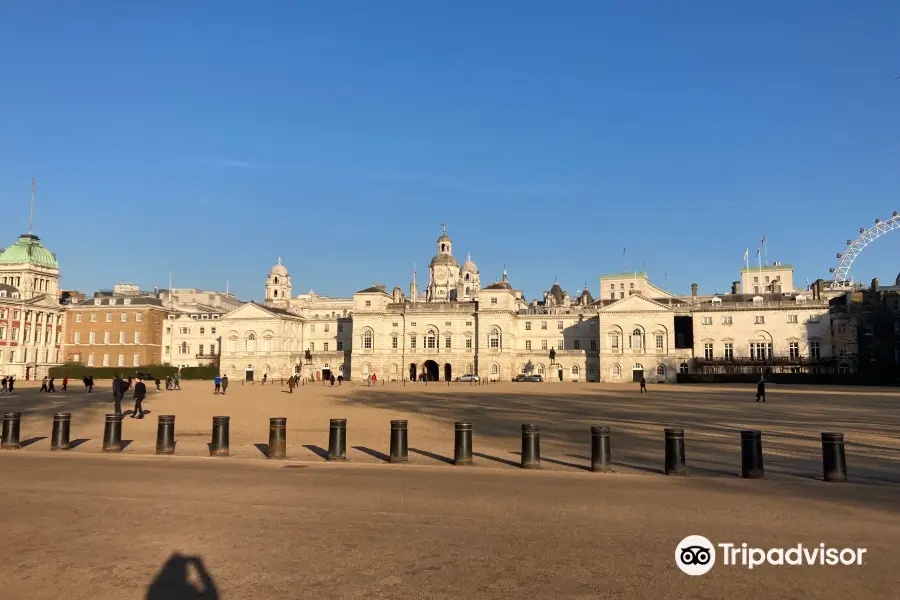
[0,228,851,382]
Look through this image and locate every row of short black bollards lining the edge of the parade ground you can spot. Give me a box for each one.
[0,412,847,482]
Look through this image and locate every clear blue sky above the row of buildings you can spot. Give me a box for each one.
[0,0,900,299]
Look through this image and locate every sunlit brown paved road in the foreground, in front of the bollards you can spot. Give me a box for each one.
[0,451,900,600]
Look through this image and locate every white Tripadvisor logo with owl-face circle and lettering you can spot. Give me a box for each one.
[675,535,866,575]
